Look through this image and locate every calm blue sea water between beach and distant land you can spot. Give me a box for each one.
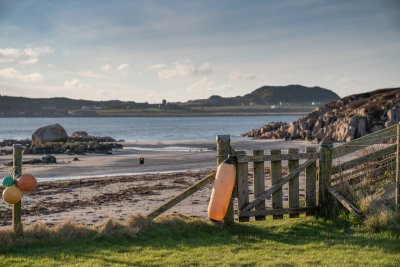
[0,116,298,141]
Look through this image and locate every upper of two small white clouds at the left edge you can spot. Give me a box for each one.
[0,46,54,65]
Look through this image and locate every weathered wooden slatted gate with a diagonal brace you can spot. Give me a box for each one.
[236,147,318,222]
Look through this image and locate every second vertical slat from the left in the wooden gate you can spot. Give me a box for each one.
[253,150,265,221]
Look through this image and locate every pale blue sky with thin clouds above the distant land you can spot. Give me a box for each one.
[0,0,400,103]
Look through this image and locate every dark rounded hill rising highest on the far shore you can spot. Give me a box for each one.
[188,85,339,106]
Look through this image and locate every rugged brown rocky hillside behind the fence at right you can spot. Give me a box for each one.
[243,87,400,142]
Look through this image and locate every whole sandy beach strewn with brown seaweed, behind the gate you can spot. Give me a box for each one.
[0,140,315,226]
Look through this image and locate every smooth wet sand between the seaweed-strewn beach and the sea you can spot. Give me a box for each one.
[0,138,316,180]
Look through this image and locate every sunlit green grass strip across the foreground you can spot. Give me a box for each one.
[0,216,400,267]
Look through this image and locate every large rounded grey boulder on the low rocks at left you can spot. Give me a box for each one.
[32,123,68,146]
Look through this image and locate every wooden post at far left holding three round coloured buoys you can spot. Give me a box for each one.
[12,144,23,234]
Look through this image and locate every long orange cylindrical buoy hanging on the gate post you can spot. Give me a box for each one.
[207,156,236,222]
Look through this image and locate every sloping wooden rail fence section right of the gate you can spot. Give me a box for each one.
[330,124,400,217]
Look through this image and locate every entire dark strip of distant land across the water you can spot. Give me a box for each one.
[0,85,339,117]
